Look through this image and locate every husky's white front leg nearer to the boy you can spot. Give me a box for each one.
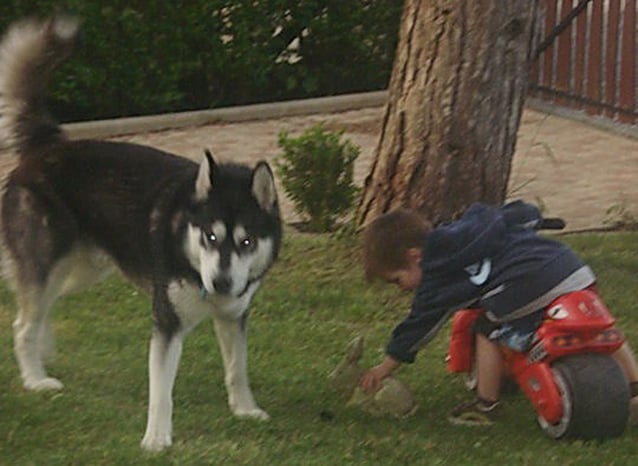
[214,318,269,420]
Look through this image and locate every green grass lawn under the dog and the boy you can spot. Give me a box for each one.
[0,233,638,465]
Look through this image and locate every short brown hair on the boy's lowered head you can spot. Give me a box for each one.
[363,208,432,280]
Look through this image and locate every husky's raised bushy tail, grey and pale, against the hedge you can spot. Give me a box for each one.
[0,17,79,154]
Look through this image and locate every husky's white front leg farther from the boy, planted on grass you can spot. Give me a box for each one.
[142,328,183,451]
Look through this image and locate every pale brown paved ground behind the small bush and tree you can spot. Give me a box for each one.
[112,107,638,230]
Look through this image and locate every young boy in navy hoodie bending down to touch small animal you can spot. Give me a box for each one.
[360,201,638,425]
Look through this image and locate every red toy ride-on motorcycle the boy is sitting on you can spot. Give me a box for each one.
[448,219,630,439]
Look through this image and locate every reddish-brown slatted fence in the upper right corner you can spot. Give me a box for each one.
[530,0,638,125]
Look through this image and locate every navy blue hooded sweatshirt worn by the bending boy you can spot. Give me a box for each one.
[386,201,595,363]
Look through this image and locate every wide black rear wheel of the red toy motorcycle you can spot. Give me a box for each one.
[538,353,630,440]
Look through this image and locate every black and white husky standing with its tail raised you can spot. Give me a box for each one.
[0,17,281,450]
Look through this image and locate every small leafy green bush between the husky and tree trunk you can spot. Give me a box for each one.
[275,124,360,232]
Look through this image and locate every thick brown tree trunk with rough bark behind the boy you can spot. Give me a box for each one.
[358,0,538,225]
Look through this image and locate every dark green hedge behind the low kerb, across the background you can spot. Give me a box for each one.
[0,0,402,121]
